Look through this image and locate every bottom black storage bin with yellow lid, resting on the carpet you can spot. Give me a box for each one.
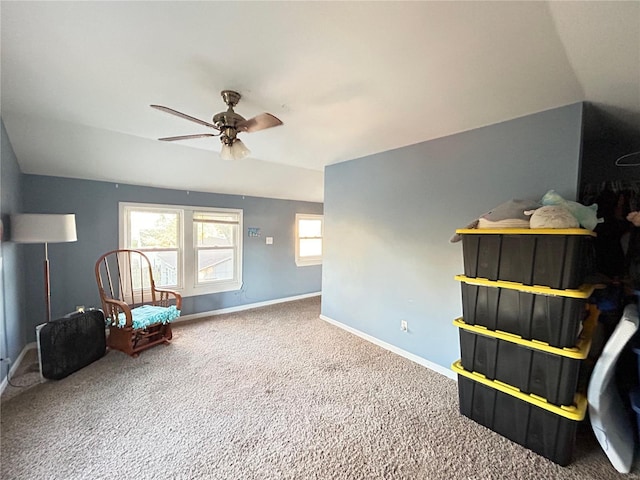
[452,362,587,466]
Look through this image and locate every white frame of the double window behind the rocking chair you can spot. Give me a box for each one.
[118,202,243,297]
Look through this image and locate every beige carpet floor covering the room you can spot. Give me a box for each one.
[0,298,640,480]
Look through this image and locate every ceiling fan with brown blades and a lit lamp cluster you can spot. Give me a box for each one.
[150,90,282,160]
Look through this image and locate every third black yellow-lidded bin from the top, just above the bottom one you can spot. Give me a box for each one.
[454,316,597,405]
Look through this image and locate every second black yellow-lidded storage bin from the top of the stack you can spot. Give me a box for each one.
[455,275,594,348]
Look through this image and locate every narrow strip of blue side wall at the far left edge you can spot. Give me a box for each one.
[0,120,28,381]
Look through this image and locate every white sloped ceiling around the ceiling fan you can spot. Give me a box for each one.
[0,0,640,201]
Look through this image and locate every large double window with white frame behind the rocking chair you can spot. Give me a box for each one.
[120,203,242,296]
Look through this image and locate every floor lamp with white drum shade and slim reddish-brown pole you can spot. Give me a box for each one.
[11,213,78,322]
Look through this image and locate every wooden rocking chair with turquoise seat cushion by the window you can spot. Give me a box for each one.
[95,250,182,357]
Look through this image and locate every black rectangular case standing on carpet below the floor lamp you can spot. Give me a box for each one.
[36,309,107,380]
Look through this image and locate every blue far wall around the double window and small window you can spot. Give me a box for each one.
[18,175,322,342]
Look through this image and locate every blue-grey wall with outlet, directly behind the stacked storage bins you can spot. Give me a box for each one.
[322,104,582,368]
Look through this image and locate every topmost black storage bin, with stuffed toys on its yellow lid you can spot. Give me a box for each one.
[456,228,595,289]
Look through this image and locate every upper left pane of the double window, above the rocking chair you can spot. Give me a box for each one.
[130,211,178,248]
